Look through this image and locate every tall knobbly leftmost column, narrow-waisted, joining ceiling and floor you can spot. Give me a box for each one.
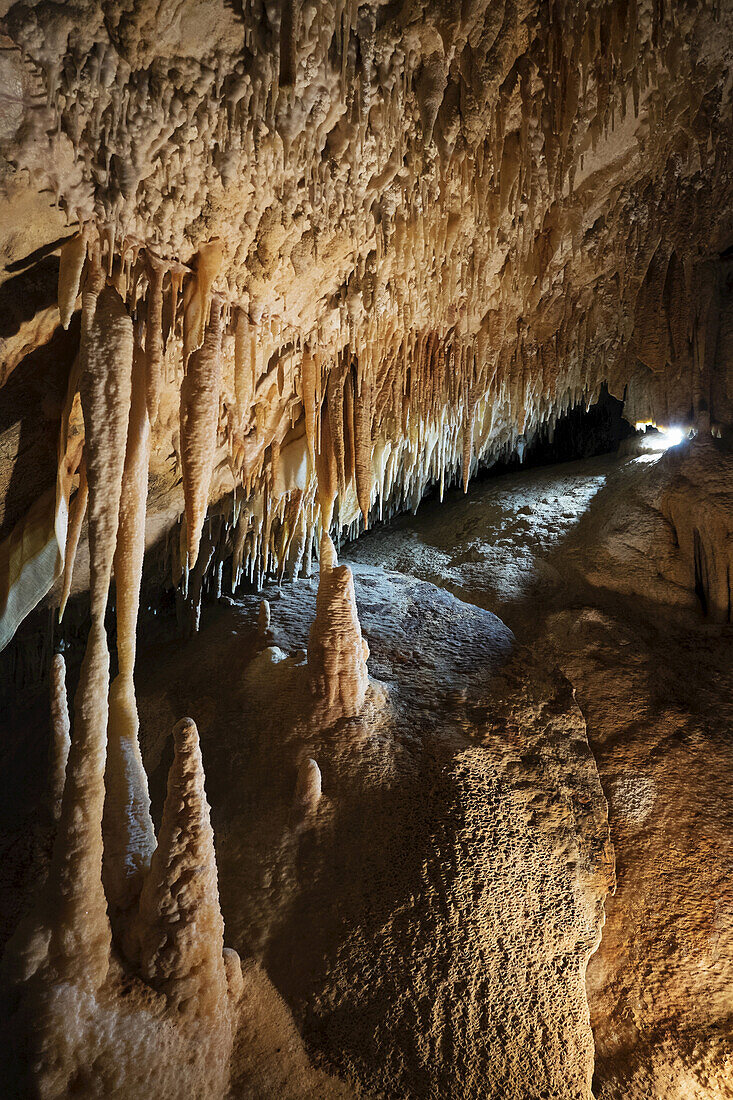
[50,265,133,989]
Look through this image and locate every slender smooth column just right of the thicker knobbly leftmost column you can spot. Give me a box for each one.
[102,344,155,928]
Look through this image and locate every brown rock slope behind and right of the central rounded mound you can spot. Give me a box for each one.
[346,440,733,1100]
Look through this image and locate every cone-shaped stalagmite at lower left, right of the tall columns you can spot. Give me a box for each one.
[135,718,227,1016]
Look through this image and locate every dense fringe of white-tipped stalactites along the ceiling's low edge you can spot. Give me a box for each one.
[172,310,600,601]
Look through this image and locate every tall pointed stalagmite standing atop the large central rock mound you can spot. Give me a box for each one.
[308,534,369,723]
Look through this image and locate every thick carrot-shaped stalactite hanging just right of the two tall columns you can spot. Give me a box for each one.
[180,297,221,569]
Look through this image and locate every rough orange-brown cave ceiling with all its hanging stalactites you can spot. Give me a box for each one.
[0,0,733,642]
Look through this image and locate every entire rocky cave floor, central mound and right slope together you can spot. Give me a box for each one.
[2,446,733,1100]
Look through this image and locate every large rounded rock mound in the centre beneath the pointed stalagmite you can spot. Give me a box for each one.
[121,568,613,1098]
